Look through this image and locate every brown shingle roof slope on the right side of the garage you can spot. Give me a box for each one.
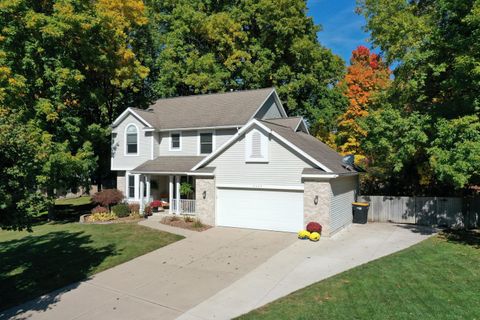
[261,121,356,173]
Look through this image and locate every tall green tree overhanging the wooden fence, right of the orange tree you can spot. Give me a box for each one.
[358,0,480,190]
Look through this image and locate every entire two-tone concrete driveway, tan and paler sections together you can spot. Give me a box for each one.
[0,222,432,320]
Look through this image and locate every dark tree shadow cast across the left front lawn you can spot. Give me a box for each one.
[0,231,118,318]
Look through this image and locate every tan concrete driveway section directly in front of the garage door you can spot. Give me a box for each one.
[0,226,297,320]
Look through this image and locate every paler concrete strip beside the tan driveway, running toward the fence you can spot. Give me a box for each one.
[178,223,434,320]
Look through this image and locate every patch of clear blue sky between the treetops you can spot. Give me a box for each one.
[307,0,371,63]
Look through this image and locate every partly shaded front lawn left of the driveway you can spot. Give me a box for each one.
[0,221,182,310]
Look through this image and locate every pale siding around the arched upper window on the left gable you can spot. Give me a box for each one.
[111,115,152,170]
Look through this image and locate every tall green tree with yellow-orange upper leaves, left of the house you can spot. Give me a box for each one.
[0,0,148,228]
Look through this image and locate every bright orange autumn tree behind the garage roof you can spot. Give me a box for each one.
[330,46,391,156]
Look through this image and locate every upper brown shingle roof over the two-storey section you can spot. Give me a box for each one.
[141,88,274,130]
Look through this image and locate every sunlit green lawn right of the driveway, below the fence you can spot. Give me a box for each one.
[239,232,480,320]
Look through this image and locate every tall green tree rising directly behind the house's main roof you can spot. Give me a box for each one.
[147,0,347,125]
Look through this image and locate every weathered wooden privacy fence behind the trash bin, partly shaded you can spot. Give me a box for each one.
[358,196,480,228]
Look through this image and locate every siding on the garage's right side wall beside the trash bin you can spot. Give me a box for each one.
[330,176,358,235]
